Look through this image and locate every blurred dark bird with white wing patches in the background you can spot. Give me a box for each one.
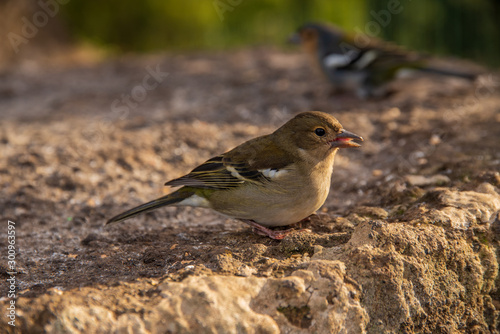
[290,23,479,99]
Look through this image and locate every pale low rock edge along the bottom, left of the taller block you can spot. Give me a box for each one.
[13,260,369,333]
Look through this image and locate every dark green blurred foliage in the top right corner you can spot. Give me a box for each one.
[369,0,500,66]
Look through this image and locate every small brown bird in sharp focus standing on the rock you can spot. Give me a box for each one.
[107,111,363,239]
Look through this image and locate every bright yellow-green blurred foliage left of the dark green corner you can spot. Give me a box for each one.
[63,0,366,51]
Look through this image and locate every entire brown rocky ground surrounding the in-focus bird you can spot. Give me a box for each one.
[0,49,500,333]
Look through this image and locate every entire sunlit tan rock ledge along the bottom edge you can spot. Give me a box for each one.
[0,184,500,333]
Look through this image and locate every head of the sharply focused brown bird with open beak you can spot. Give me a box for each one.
[275,111,363,160]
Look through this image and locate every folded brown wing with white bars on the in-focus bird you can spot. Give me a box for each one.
[165,138,292,190]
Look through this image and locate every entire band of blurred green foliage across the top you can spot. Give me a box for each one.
[62,0,500,65]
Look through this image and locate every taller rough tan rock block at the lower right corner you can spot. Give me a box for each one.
[313,222,498,333]
